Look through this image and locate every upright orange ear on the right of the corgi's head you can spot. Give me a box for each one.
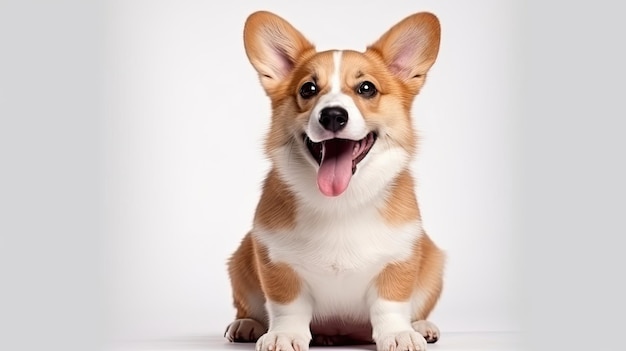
[366,12,441,93]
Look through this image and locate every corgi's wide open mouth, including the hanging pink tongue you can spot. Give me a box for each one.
[304,132,376,196]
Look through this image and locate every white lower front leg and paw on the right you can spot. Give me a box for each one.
[370,296,426,351]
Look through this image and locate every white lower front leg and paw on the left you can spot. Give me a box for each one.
[256,295,313,351]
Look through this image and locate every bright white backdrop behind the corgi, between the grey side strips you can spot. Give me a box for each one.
[101,0,522,339]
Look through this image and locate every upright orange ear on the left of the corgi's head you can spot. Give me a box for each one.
[243,11,315,94]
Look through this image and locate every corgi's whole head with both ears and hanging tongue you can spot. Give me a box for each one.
[244,12,440,196]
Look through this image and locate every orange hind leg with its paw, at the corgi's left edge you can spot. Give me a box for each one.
[224,234,267,342]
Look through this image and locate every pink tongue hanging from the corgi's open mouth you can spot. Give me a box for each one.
[317,139,354,196]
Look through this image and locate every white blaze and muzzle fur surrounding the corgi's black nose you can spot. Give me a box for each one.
[306,50,369,142]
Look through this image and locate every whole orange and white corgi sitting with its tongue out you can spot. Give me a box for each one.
[225,11,445,351]
